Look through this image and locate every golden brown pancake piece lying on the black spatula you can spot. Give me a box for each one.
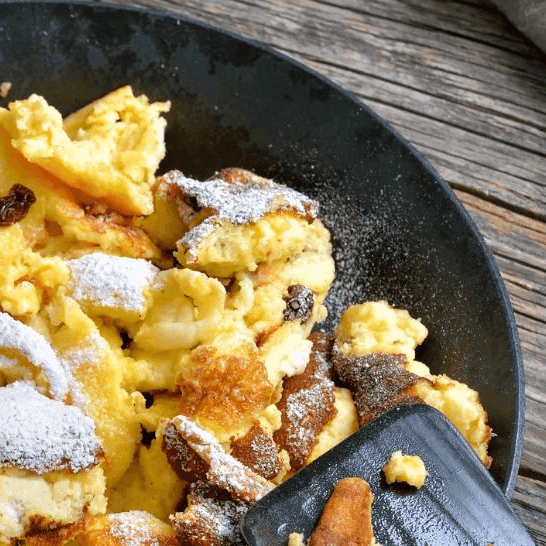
[308,478,375,546]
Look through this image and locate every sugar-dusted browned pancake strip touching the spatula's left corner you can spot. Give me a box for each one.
[163,415,273,504]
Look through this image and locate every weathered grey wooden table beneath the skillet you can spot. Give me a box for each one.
[106,0,546,545]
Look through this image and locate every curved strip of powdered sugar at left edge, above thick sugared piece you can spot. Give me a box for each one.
[0,312,68,400]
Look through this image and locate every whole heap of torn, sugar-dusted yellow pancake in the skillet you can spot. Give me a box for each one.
[0,86,491,546]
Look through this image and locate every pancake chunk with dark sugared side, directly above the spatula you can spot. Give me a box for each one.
[332,302,492,467]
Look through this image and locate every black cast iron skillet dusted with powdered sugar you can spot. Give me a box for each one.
[0,2,524,497]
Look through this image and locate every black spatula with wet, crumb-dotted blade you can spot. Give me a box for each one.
[243,404,534,546]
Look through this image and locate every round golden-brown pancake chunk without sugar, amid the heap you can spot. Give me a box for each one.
[177,335,273,441]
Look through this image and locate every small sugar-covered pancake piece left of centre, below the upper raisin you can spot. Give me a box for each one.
[67,252,160,313]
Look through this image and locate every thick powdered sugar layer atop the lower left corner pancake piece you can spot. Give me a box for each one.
[0,381,101,474]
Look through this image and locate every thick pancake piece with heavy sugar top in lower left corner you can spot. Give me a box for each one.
[0,382,106,544]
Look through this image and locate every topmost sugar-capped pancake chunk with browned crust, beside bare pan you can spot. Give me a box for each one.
[154,169,330,277]
